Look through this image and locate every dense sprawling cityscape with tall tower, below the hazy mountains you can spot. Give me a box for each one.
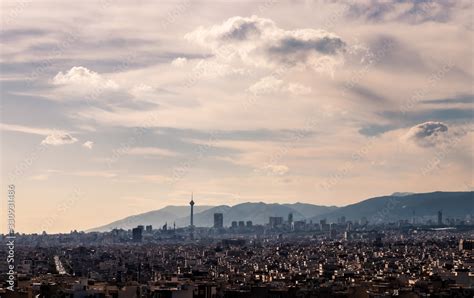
[0,197,474,298]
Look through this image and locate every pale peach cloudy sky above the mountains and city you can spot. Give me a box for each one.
[0,0,474,233]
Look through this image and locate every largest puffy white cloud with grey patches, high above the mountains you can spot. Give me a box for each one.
[185,16,346,74]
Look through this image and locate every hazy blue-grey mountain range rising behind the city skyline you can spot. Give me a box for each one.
[88,191,474,232]
